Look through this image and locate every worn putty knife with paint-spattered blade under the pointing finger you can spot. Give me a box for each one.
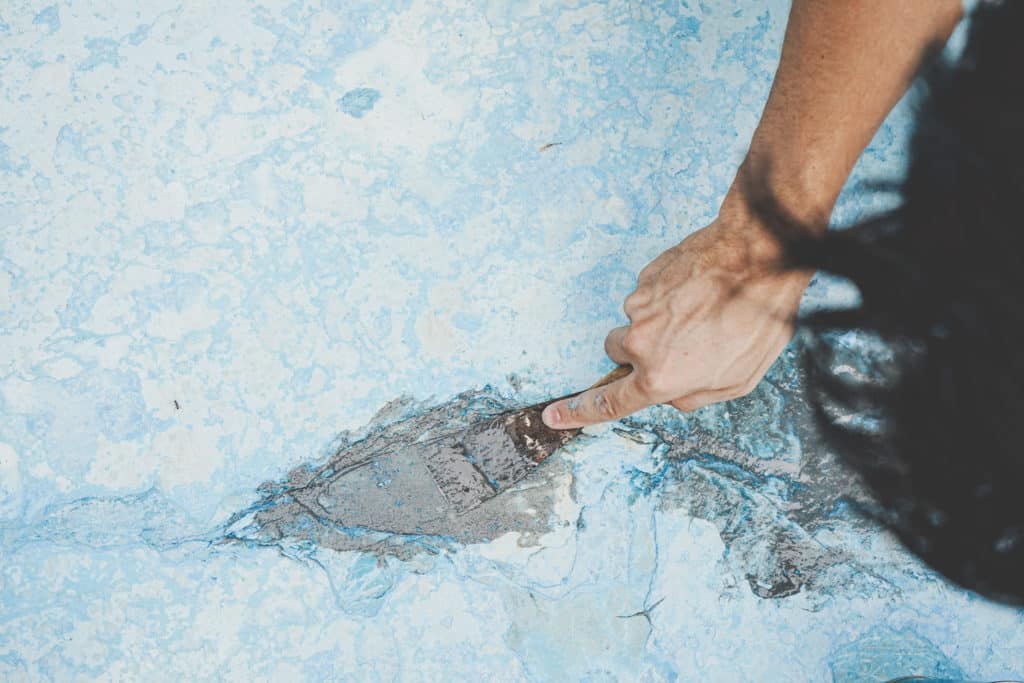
[423,366,633,512]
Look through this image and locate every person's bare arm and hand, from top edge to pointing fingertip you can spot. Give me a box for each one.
[544,0,961,429]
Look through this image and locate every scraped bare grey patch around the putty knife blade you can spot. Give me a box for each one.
[221,392,571,557]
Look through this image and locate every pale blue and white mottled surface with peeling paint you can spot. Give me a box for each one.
[0,0,1024,681]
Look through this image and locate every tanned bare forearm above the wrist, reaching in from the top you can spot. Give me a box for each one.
[726,0,961,229]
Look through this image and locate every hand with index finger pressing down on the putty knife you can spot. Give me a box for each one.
[543,197,812,429]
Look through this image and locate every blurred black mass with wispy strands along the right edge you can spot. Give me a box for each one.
[773,1,1024,604]
